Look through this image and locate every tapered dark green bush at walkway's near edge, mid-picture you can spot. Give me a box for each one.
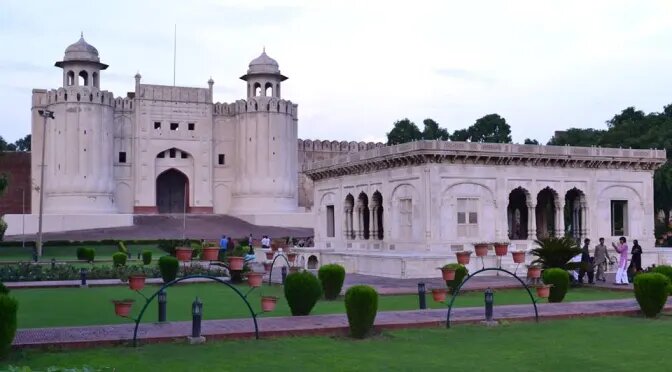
[345,285,378,338]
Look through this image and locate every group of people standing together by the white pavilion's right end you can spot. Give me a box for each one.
[573,237,642,285]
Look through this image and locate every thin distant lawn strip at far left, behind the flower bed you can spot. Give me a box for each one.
[0,243,165,261]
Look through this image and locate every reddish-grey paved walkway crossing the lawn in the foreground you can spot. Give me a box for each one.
[14,300,672,348]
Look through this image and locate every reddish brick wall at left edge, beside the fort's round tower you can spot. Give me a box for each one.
[0,152,31,215]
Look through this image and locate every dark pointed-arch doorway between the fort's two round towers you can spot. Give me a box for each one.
[156,168,189,213]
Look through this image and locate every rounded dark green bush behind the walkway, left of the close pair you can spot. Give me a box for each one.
[285,271,322,316]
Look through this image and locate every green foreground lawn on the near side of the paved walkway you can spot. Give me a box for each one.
[0,317,672,372]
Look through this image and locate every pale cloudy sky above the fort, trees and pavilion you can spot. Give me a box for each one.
[0,0,672,142]
